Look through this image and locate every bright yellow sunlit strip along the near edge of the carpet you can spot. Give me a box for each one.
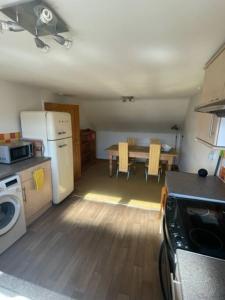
[83,193,160,211]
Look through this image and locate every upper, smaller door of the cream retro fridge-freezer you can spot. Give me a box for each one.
[47,111,72,141]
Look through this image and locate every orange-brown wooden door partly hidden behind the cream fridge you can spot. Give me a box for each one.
[44,102,81,180]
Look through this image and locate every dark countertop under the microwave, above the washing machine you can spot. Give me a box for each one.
[0,157,51,180]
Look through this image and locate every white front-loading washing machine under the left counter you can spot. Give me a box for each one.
[0,175,26,254]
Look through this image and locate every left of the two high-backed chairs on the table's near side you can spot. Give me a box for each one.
[116,143,132,179]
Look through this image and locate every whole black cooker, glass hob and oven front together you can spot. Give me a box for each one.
[159,197,225,300]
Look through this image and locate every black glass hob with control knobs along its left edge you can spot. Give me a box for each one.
[166,197,225,259]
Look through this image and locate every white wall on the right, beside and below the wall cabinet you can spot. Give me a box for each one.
[180,95,219,174]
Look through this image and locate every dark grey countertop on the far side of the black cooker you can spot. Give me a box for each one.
[166,171,225,201]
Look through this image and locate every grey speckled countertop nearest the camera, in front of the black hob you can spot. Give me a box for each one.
[176,249,225,300]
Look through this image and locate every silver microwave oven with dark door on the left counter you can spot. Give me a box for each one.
[0,141,33,164]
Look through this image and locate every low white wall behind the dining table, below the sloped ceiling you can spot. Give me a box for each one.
[97,131,179,159]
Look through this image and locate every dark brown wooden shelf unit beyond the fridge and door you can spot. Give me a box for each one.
[80,129,96,170]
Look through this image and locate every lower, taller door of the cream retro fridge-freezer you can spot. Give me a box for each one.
[48,138,74,204]
